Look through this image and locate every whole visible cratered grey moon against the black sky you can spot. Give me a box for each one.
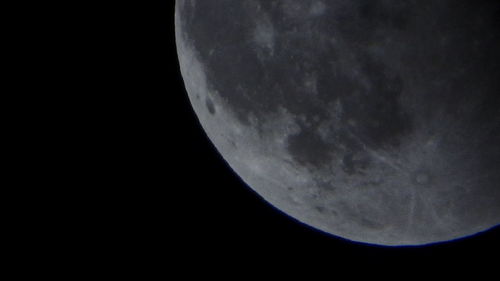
[176,0,500,245]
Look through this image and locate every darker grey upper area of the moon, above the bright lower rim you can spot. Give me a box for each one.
[179,0,500,243]
